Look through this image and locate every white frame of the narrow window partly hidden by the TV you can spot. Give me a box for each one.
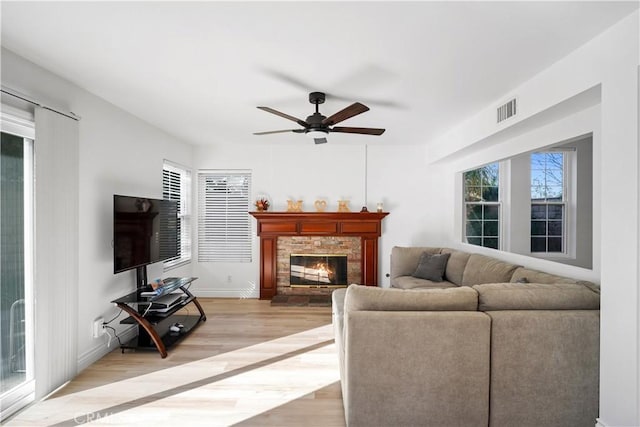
[162,159,193,271]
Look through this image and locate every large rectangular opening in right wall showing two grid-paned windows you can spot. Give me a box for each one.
[455,133,595,269]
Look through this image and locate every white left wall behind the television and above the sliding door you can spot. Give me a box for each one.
[2,49,192,370]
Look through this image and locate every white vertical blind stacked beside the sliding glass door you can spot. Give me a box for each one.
[34,107,79,399]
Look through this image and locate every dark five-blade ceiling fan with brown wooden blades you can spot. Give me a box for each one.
[254,92,385,144]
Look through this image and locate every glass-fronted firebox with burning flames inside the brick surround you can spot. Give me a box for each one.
[289,254,347,288]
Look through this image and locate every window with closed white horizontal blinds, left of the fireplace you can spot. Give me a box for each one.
[198,171,251,262]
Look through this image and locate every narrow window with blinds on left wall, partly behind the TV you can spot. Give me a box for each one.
[161,160,191,270]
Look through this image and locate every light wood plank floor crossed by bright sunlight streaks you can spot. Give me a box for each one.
[7,298,345,427]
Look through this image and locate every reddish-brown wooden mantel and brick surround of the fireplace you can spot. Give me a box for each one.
[250,212,388,299]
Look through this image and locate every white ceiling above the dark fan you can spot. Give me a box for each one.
[0,1,638,144]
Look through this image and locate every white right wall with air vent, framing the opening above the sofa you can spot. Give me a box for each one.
[427,11,640,426]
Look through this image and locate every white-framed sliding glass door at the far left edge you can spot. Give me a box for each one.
[0,114,35,419]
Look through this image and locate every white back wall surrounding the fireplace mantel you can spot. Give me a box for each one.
[192,142,429,298]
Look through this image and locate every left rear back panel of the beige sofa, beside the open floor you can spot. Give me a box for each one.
[343,311,491,427]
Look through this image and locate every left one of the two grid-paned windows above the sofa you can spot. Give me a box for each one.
[463,163,500,249]
